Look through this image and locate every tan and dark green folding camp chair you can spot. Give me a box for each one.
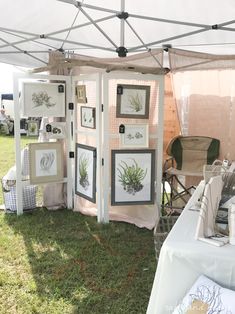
[162,136,220,213]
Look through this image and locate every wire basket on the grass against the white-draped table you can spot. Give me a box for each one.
[154,215,179,260]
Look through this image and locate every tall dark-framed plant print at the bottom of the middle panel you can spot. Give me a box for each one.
[75,144,96,203]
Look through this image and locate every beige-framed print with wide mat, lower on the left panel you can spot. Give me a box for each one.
[29,142,64,184]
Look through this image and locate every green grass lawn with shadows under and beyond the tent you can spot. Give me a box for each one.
[0,137,156,314]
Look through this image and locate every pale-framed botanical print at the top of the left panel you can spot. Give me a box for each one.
[22,82,65,117]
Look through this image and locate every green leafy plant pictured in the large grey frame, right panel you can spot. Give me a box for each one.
[117,158,147,195]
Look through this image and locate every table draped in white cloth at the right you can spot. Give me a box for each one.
[147,183,235,314]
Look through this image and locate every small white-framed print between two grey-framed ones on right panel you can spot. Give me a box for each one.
[120,124,149,148]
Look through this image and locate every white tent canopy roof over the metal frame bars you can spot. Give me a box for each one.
[0,0,235,68]
